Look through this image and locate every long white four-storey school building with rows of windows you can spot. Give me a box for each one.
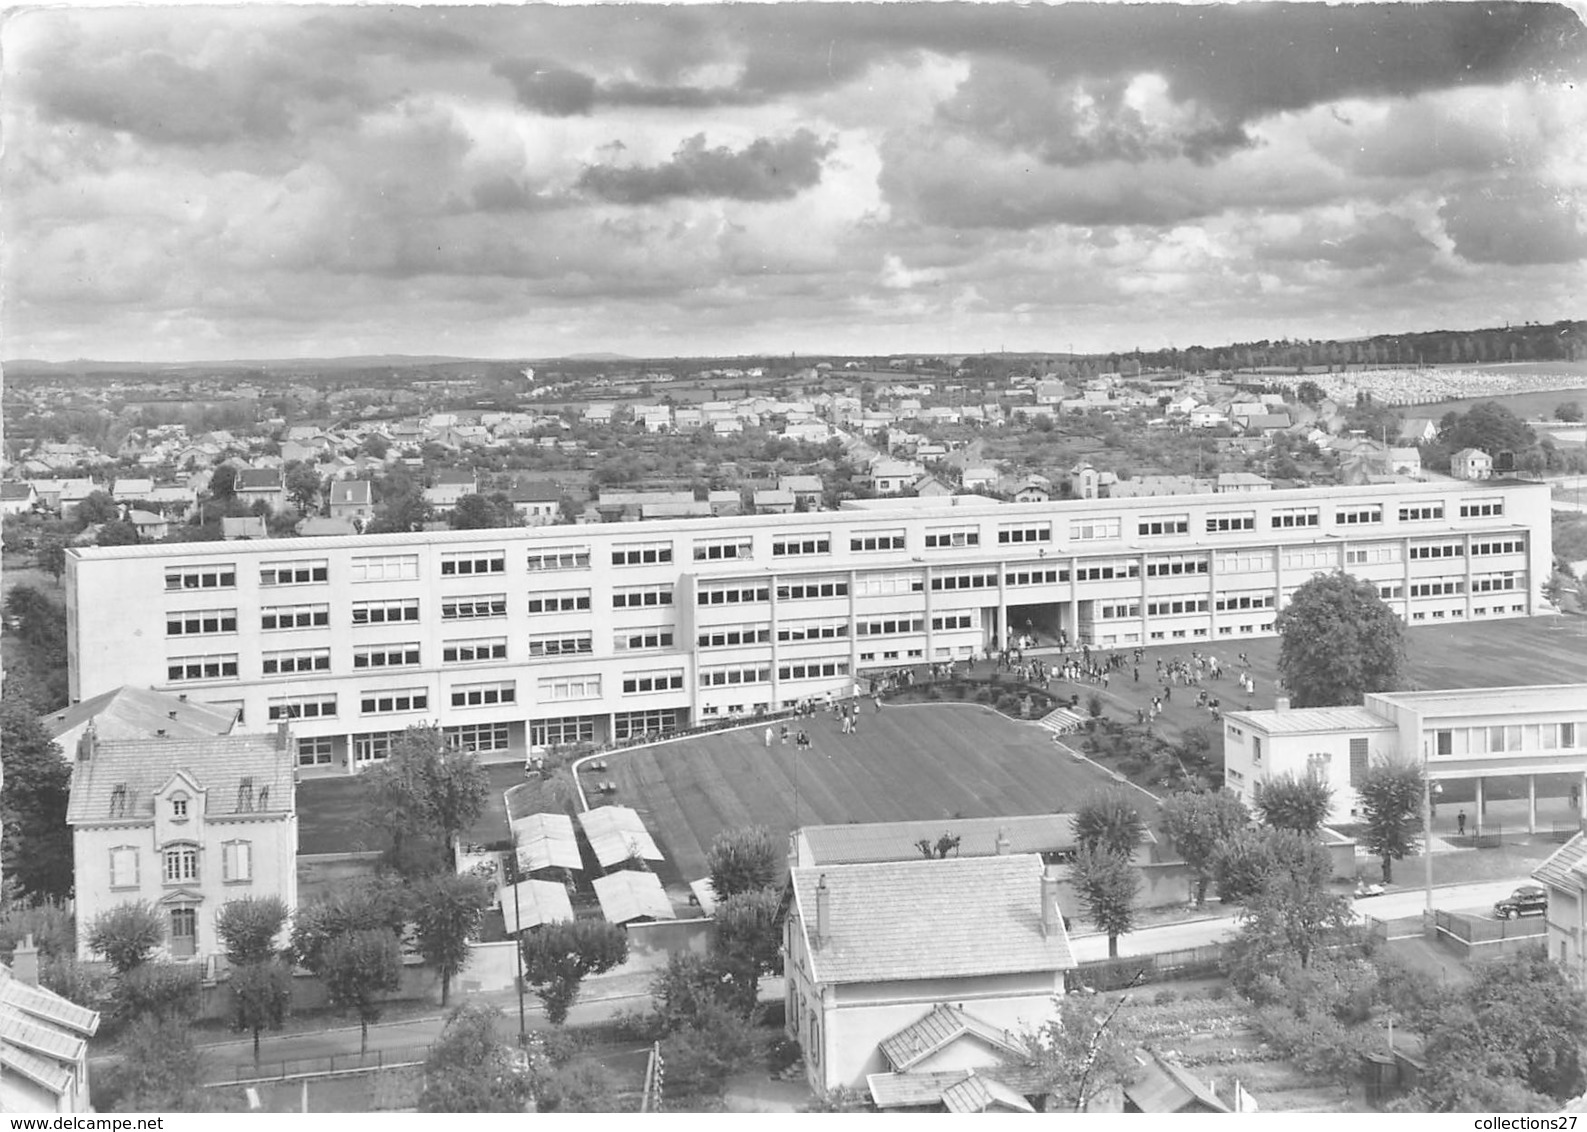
[65,481,1550,773]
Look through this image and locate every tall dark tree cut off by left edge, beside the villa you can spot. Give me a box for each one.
[0,692,71,900]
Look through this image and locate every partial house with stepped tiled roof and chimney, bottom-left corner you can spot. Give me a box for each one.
[0,935,100,1113]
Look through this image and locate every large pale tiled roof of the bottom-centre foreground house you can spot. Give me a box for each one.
[790,854,1074,983]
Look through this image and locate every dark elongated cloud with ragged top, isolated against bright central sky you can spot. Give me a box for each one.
[578,130,833,205]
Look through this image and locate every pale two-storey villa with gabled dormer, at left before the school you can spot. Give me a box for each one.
[67,722,297,961]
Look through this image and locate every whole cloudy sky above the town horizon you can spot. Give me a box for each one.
[0,3,1587,362]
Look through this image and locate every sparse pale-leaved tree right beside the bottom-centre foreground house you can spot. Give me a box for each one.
[1025,994,1138,1113]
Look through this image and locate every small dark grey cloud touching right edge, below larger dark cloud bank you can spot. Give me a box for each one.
[1438,184,1587,265]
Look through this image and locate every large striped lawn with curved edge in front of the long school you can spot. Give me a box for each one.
[605,705,1129,888]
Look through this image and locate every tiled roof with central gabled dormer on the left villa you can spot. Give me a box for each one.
[67,735,294,826]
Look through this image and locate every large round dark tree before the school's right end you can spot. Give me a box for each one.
[1276,572,1406,708]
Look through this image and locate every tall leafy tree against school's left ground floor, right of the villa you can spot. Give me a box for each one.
[363,724,489,876]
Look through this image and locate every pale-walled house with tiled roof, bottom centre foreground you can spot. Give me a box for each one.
[782,854,1074,1094]
